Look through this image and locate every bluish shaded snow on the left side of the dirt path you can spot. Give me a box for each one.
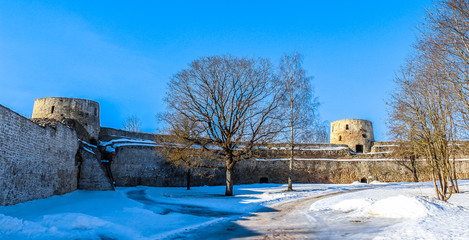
[0,184,366,239]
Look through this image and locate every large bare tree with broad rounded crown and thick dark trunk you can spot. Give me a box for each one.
[165,55,279,196]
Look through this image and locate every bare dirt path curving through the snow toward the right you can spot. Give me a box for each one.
[174,187,375,239]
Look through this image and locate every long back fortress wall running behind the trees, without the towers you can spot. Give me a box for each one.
[101,128,469,187]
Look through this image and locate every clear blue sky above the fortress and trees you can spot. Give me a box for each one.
[0,0,431,140]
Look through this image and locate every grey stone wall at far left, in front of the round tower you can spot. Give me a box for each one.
[0,105,78,205]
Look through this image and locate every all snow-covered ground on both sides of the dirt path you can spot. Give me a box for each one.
[0,181,469,239]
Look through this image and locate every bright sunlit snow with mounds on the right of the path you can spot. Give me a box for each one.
[308,180,469,239]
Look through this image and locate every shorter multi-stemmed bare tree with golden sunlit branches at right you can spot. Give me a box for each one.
[389,41,457,201]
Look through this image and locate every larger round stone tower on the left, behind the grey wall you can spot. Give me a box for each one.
[32,97,100,142]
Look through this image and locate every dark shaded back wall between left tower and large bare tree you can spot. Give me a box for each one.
[100,128,224,187]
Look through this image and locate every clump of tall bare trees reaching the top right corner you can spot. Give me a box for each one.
[389,0,469,201]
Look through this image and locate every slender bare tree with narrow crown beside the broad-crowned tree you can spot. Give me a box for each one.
[279,52,319,191]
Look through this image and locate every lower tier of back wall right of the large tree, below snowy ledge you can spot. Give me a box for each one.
[235,159,469,184]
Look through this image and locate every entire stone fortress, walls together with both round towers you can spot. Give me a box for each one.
[0,97,469,205]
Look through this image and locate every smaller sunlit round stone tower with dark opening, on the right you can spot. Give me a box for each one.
[330,119,374,153]
